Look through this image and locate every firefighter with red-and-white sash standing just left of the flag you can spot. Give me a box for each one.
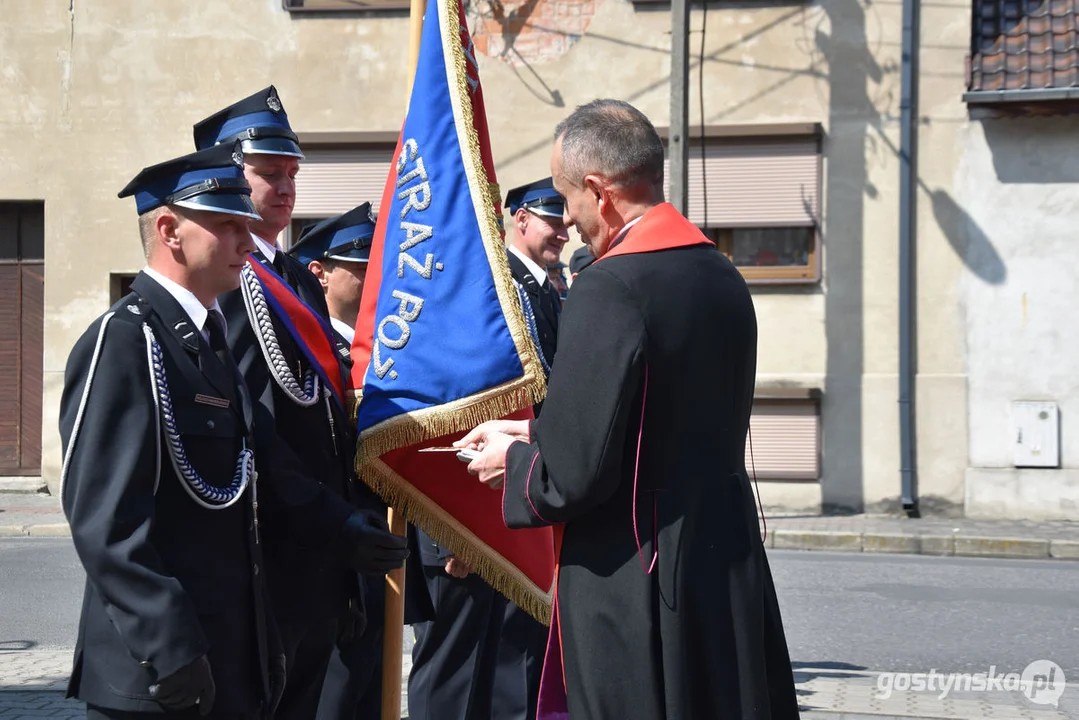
[194,85,408,720]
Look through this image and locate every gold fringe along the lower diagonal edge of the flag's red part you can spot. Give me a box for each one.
[360,460,554,626]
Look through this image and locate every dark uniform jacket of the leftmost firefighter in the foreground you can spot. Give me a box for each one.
[59,273,281,714]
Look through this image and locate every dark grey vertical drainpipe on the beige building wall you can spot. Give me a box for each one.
[899,0,919,517]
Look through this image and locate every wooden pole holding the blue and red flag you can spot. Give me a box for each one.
[382,0,427,720]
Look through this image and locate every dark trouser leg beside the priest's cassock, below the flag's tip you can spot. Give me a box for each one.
[491,600,548,720]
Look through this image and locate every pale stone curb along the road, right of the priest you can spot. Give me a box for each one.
[765,529,1079,560]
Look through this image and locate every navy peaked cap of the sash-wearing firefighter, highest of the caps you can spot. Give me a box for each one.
[194,85,303,158]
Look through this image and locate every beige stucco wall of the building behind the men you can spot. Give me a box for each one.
[6,0,988,518]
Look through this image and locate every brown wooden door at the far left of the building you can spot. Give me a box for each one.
[0,203,45,475]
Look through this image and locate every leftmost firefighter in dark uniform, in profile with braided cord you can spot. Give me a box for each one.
[59,145,284,720]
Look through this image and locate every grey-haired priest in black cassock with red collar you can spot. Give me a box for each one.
[459,100,798,720]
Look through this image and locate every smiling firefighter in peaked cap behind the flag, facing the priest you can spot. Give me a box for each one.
[406,178,569,720]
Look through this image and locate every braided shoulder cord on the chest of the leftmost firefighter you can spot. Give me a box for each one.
[142,325,255,510]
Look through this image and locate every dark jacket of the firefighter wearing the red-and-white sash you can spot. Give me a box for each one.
[219,252,358,623]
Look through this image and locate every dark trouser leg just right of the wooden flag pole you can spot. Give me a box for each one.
[408,566,506,720]
